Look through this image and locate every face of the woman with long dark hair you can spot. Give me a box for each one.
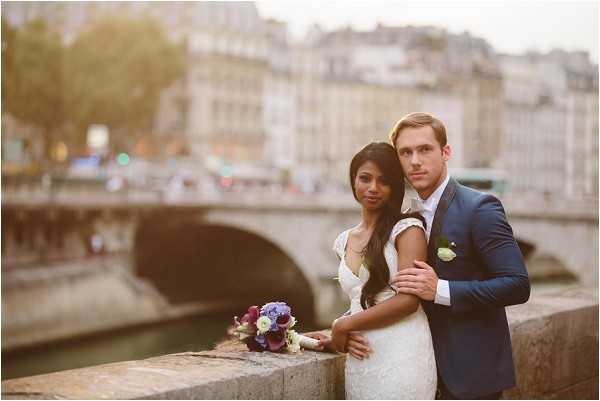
[354,161,392,210]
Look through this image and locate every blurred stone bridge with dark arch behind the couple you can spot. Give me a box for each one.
[2,191,598,324]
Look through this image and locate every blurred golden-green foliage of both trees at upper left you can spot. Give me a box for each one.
[2,16,185,155]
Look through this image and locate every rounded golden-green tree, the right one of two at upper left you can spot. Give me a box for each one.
[66,16,184,148]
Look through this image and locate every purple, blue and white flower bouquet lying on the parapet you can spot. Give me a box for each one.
[230,302,319,352]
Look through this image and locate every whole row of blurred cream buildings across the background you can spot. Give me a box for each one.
[2,2,598,199]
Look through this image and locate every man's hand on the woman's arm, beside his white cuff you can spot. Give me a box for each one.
[392,260,438,301]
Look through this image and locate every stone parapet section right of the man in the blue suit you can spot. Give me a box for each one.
[504,287,598,400]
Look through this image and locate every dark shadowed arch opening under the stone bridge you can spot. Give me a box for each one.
[133,215,315,322]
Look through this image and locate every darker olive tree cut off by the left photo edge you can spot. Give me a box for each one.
[2,20,65,157]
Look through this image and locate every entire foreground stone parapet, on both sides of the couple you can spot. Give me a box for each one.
[2,288,598,399]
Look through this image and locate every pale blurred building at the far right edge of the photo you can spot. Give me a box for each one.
[501,51,598,202]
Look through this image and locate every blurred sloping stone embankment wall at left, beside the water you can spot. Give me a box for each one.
[2,255,247,352]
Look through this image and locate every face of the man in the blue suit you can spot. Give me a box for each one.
[395,126,450,199]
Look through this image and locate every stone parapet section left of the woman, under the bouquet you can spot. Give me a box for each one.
[2,343,345,399]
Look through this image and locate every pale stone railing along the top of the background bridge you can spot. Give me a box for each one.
[2,181,598,220]
